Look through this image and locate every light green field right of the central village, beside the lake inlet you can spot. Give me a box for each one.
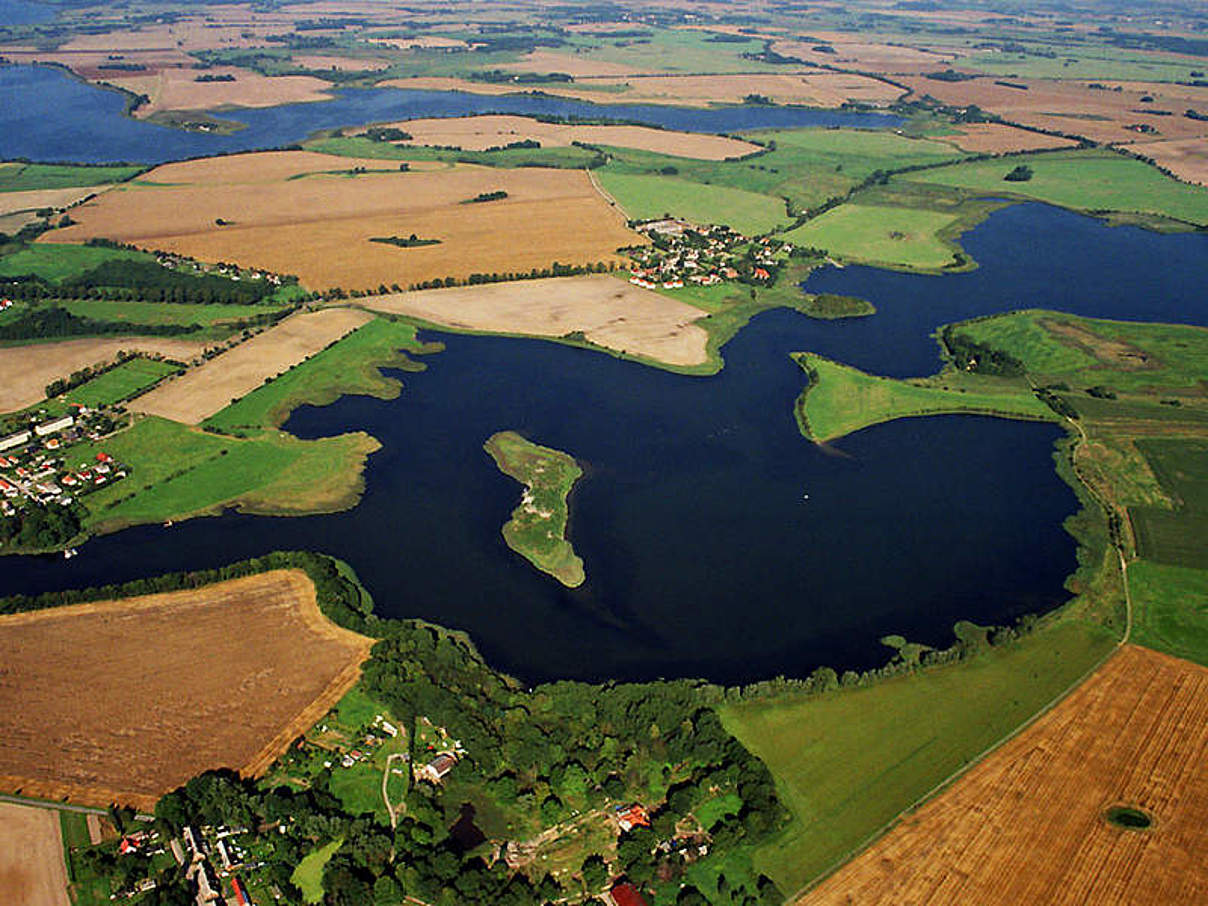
[783,204,960,271]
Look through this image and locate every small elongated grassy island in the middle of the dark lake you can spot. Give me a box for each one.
[483,431,585,588]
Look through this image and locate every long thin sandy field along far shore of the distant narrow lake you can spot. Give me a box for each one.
[382,70,902,108]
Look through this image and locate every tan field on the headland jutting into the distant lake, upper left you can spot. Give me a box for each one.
[108,66,331,117]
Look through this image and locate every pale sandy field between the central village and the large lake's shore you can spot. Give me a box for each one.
[359,274,708,366]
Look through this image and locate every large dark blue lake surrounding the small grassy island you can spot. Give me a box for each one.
[2,205,1208,683]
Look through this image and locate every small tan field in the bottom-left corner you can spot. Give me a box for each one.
[0,802,70,906]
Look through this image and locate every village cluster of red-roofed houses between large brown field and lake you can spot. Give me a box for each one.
[627,217,792,290]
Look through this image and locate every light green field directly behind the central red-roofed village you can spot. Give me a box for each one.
[599,170,789,236]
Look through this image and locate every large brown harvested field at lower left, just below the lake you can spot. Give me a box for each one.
[0,570,373,809]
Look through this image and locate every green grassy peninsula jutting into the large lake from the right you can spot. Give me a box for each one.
[794,353,1053,443]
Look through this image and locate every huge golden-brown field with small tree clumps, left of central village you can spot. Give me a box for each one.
[43,151,645,290]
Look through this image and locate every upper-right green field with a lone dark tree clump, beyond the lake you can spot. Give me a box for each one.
[898,151,1208,226]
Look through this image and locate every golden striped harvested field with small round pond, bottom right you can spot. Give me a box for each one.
[798,645,1208,906]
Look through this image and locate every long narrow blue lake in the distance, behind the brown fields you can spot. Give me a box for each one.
[0,66,901,163]
